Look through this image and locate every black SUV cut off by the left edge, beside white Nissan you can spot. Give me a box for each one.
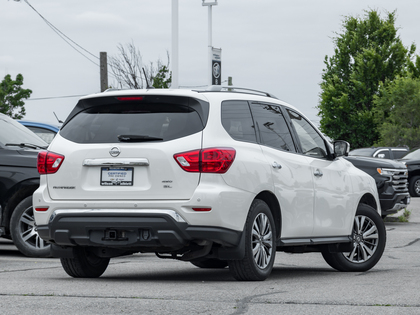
[0,114,50,257]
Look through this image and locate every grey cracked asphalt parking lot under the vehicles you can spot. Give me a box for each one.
[0,198,420,314]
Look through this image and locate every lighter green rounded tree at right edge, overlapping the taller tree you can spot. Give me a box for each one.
[374,76,420,148]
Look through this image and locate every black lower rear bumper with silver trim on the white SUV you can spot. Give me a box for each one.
[37,209,242,252]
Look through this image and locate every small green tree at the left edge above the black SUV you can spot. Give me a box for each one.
[0,73,32,119]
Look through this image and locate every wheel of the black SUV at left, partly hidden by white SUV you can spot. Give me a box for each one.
[10,196,51,257]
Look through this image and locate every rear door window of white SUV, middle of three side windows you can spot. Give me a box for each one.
[251,103,296,152]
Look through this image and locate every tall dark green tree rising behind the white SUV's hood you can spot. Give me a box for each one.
[318,10,416,148]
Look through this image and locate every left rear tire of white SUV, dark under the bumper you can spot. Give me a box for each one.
[60,247,110,278]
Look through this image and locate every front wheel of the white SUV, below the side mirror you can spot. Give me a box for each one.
[322,204,386,271]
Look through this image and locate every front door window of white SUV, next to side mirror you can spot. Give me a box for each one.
[287,110,328,158]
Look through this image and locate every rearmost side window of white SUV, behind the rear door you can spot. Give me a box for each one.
[222,101,257,143]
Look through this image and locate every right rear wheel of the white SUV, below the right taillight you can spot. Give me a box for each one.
[229,199,276,281]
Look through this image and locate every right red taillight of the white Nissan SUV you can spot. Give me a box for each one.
[174,148,236,174]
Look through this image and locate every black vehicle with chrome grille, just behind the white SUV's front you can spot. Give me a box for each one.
[346,156,410,218]
